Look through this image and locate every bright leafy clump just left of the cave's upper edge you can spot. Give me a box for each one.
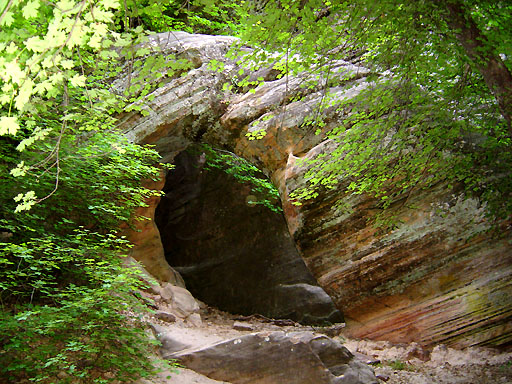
[0,132,159,226]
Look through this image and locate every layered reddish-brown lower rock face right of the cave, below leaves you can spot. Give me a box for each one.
[286,175,512,347]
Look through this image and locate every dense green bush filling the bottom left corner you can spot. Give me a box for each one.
[0,229,162,383]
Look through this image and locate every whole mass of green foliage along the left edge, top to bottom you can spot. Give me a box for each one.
[0,0,186,383]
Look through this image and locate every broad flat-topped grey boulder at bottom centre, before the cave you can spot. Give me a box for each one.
[163,331,377,384]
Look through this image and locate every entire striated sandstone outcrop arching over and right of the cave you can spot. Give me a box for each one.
[124,33,512,347]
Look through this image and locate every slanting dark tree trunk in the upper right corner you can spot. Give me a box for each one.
[438,0,512,136]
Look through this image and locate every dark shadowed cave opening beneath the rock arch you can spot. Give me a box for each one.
[155,146,343,324]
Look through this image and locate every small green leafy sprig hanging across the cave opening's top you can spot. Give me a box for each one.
[201,144,282,212]
